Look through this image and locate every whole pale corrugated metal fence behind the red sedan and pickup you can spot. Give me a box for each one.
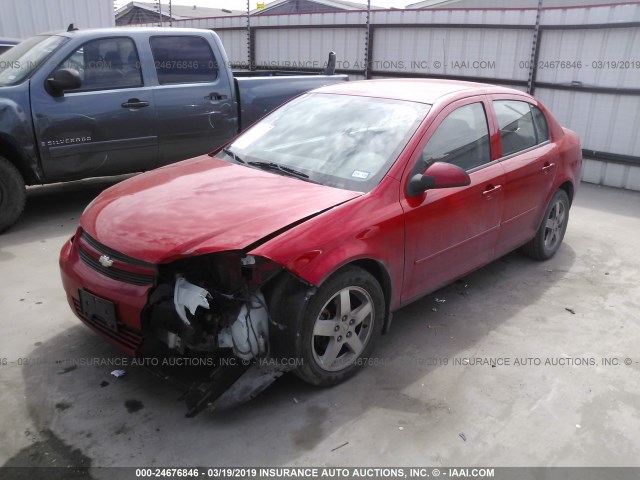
[129,3,640,190]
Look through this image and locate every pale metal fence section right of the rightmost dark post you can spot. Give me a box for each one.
[535,3,640,190]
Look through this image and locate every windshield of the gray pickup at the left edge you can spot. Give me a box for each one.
[0,35,68,87]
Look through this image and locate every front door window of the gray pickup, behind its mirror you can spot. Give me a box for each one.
[57,37,142,90]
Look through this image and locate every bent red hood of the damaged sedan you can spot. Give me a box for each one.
[80,155,362,263]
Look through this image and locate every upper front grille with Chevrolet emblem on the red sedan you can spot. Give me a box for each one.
[78,231,156,285]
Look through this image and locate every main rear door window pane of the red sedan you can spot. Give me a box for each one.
[493,100,539,157]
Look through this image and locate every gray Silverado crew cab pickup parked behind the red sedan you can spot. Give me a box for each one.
[0,26,348,232]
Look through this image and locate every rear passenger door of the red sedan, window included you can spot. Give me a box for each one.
[492,96,557,254]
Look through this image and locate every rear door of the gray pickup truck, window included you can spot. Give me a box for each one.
[149,35,238,165]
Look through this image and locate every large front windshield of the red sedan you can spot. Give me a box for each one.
[216,93,430,192]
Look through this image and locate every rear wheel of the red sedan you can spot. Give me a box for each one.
[522,189,569,260]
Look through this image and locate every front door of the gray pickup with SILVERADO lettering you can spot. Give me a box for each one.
[31,36,158,180]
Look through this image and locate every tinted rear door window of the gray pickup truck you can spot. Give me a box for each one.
[149,36,218,85]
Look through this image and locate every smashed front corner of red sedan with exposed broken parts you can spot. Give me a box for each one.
[138,251,315,416]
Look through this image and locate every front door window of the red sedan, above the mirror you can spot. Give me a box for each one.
[416,103,491,173]
